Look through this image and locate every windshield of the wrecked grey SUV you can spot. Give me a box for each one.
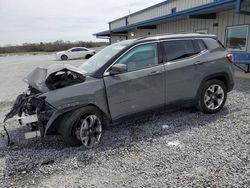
[79,40,134,73]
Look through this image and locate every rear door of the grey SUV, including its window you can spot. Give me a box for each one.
[162,39,206,104]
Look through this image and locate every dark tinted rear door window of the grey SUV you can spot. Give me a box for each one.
[163,40,197,61]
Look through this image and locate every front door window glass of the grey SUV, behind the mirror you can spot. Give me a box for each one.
[116,43,158,72]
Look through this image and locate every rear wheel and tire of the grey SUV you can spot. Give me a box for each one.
[197,79,227,114]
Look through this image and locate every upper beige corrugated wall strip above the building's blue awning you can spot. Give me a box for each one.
[110,0,214,29]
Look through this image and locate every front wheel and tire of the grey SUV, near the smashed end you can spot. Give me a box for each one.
[58,107,103,148]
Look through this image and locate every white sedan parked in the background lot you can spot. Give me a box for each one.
[56,47,95,61]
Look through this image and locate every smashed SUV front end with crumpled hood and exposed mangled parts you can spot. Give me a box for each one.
[1,64,85,143]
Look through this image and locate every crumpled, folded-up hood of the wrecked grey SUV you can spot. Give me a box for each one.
[23,64,86,93]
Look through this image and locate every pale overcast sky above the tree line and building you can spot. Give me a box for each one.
[0,0,163,46]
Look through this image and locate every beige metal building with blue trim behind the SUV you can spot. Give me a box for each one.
[94,0,250,52]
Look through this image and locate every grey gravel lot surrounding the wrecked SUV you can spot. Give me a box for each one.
[0,56,250,188]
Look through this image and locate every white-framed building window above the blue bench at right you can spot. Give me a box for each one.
[226,25,249,51]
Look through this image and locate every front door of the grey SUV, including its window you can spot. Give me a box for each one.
[104,42,165,119]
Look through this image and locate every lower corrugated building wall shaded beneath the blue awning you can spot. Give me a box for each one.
[128,6,250,51]
